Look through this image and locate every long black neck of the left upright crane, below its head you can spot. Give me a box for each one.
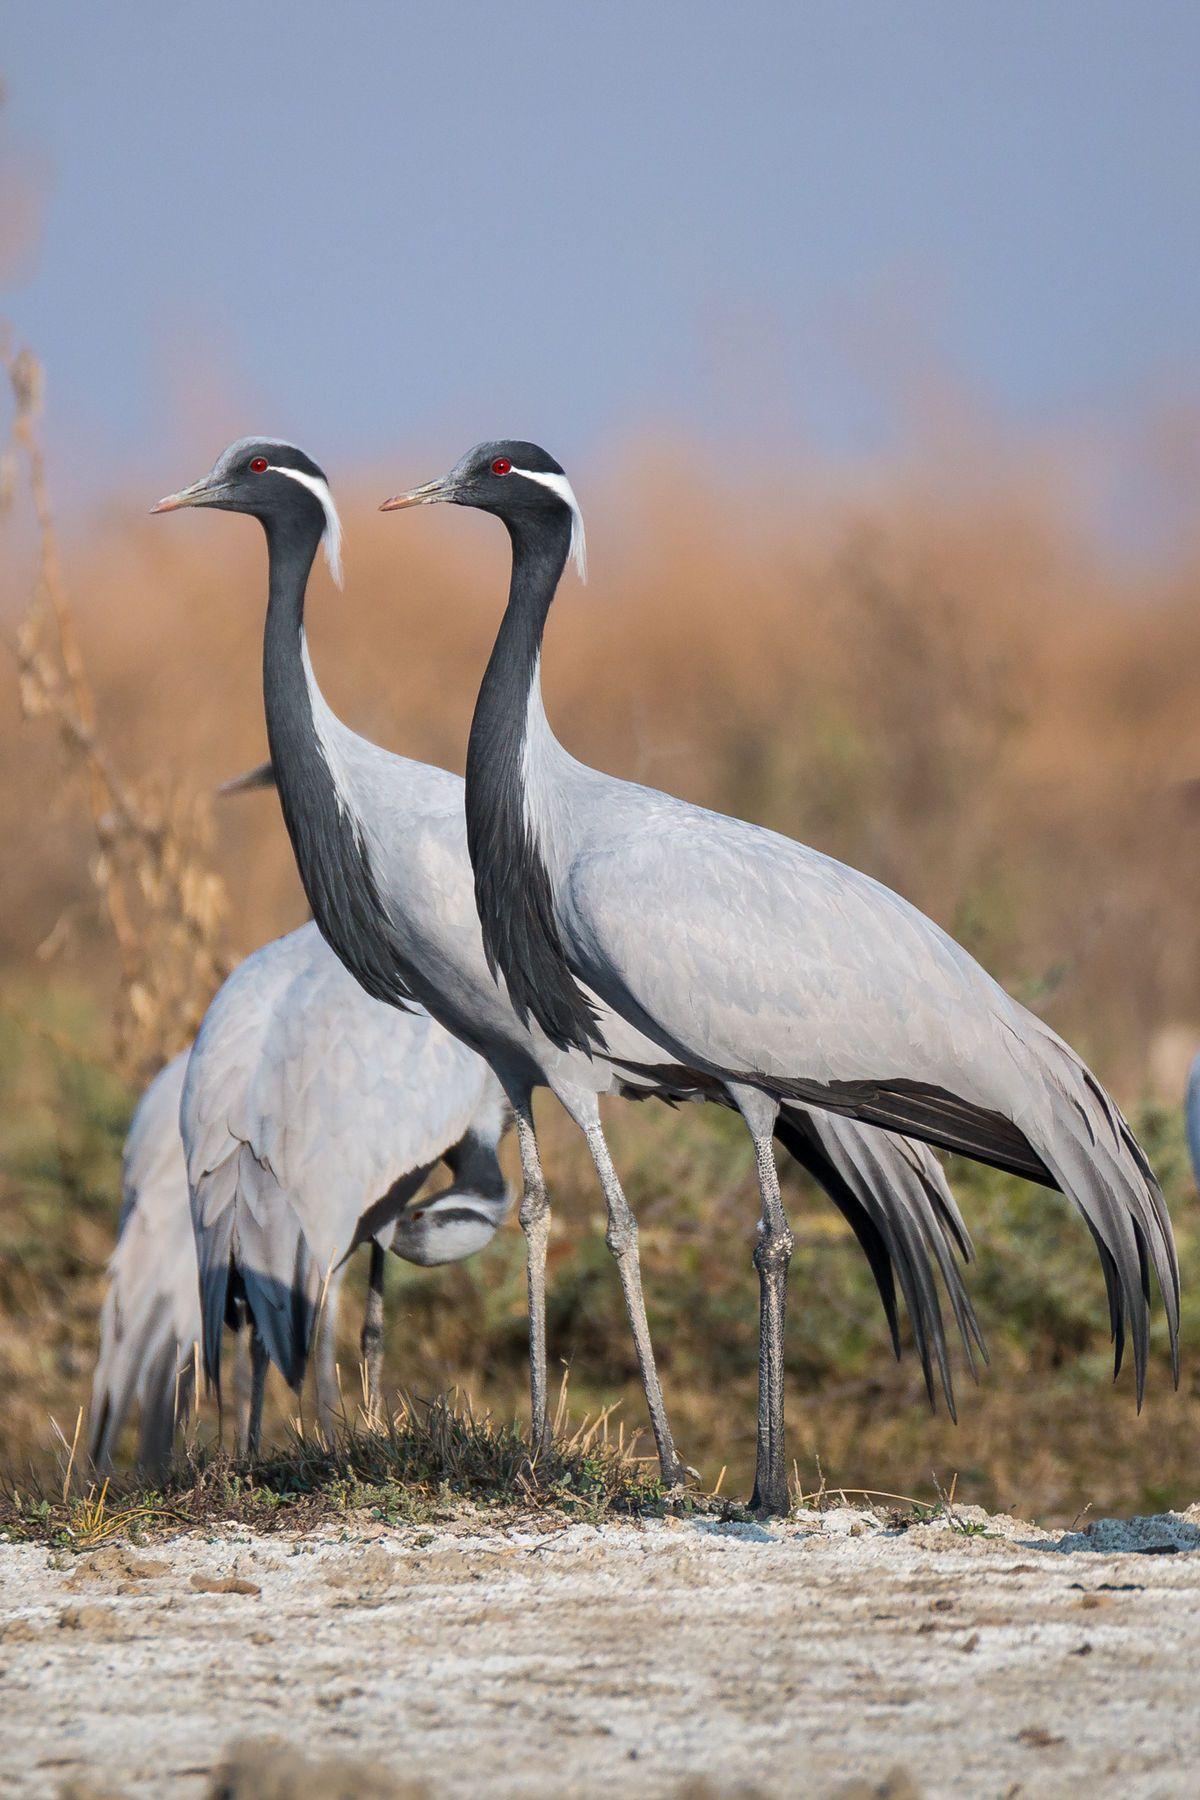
[263,520,412,1004]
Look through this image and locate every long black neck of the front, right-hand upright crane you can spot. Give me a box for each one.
[466,517,601,1051]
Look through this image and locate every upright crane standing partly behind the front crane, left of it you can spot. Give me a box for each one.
[155,437,982,1483]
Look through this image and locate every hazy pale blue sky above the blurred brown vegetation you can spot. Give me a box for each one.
[0,0,1200,511]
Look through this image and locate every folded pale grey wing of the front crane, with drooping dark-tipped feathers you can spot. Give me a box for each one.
[558,783,1178,1397]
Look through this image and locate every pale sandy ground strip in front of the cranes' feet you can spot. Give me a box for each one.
[0,1508,1200,1800]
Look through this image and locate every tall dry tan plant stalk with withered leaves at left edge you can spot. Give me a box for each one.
[0,337,228,1082]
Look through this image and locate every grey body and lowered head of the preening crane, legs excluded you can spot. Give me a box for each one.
[180,925,507,1386]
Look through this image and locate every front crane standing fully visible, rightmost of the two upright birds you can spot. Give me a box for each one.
[383,441,1178,1512]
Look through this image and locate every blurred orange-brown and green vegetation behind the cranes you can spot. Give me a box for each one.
[0,338,1200,1517]
